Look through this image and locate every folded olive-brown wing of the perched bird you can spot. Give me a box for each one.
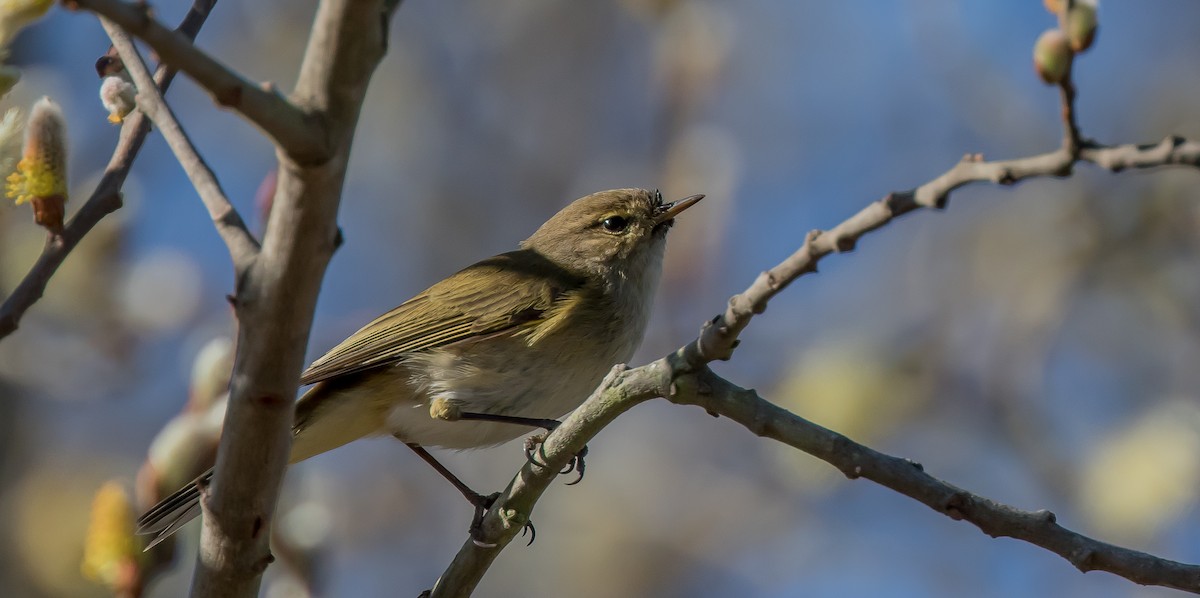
[300,250,583,384]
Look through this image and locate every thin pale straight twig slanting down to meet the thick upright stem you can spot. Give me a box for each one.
[100,17,259,277]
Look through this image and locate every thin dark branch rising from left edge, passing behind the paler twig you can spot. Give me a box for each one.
[0,0,216,340]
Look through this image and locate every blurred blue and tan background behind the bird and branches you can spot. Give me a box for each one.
[0,0,1200,598]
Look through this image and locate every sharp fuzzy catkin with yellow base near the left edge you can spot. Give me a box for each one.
[7,97,67,233]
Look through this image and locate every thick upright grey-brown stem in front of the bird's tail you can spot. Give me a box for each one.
[192,0,395,598]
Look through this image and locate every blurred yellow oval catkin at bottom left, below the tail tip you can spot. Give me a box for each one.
[80,482,139,592]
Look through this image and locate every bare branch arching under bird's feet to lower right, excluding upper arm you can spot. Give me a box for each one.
[432,358,1200,598]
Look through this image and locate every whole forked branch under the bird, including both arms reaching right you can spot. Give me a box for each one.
[431,73,1200,598]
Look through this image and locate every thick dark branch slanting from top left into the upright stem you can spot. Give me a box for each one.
[71,0,330,163]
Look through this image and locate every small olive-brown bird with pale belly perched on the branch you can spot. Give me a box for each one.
[138,189,704,550]
